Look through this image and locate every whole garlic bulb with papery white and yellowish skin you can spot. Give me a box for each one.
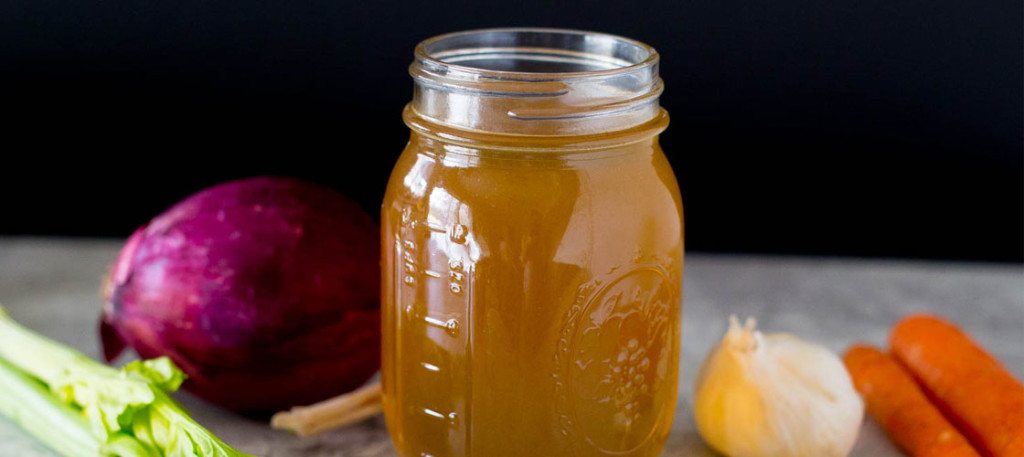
[694,316,864,457]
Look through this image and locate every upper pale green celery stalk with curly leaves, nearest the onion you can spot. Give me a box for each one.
[0,307,246,457]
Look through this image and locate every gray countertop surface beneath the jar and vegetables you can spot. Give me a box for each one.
[0,238,1024,457]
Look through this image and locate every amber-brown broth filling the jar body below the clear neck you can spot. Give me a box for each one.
[382,109,683,457]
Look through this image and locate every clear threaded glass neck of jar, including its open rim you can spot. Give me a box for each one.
[407,29,664,136]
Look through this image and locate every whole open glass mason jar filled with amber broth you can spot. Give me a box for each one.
[381,29,683,457]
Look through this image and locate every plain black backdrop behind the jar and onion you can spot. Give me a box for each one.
[0,0,1024,261]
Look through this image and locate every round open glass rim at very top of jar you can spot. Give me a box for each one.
[413,28,658,81]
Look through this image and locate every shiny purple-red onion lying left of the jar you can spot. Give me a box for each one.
[101,177,380,414]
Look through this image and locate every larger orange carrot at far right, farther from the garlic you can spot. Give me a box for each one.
[889,315,1024,457]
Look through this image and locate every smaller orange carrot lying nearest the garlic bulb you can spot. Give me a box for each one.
[843,345,978,457]
